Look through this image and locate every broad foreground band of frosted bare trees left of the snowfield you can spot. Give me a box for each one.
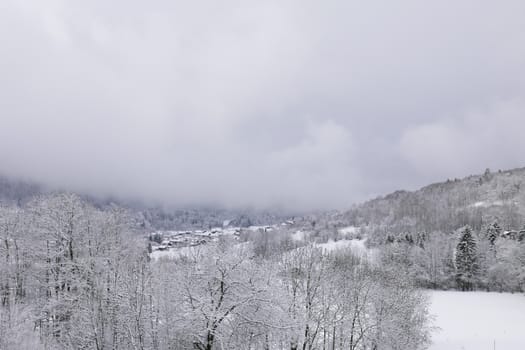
[0,194,428,350]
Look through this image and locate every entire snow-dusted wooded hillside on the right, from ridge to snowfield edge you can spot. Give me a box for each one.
[322,168,525,291]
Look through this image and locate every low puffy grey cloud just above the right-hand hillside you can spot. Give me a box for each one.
[400,99,525,177]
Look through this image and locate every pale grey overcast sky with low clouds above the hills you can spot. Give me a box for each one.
[0,0,525,210]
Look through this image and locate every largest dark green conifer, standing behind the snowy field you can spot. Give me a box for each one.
[455,226,478,291]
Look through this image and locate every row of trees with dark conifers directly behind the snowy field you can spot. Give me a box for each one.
[377,222,525,292]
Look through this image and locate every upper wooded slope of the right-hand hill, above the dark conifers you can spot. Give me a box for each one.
[340,169,525,239]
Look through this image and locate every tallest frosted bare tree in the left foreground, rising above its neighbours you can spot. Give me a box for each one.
[30,194,87,342]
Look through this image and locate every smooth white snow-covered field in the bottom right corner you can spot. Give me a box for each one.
[429,292,525,350]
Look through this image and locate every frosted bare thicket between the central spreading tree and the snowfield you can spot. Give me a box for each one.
[279,246,428,350]
